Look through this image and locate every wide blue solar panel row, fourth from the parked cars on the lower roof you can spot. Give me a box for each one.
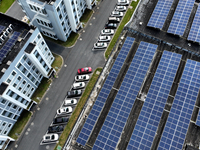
[158,60,200,150]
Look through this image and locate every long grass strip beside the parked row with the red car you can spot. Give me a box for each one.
[54,68,102,150]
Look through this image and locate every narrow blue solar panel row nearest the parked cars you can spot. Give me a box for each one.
[77,37,135,145]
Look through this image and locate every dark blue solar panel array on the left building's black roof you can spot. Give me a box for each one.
[0,31,21,62]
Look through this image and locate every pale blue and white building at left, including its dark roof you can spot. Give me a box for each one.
[0,13,54,149]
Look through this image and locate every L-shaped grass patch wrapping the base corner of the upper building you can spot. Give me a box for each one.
[43,32,79,47]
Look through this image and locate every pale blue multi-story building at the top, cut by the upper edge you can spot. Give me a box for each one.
[17,0,96,41]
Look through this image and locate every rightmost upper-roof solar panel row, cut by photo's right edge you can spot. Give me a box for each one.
[188,7,200,43]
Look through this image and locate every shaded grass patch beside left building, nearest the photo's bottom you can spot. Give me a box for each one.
[8,109,31,140]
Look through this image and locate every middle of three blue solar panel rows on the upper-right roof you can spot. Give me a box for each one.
[167,0,195,36]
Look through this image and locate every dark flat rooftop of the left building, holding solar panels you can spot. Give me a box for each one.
[0,13,35,77]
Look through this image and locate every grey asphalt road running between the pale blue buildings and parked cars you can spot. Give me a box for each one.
[7,0,117,150]
